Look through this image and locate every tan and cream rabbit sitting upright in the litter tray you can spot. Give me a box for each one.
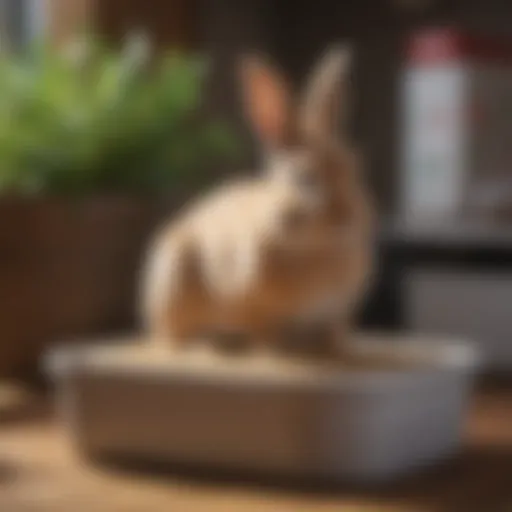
[142,47,373,356]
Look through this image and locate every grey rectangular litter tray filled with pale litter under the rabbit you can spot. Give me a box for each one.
[47,335,477,482]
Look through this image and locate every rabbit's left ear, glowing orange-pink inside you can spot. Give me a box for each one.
[240,57,291,147]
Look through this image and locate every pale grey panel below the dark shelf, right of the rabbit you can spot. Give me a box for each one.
[403,268,512,369]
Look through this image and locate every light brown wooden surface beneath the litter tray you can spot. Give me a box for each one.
[0,388,512,512]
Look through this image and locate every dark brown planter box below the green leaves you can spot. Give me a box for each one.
[0,198,172,376]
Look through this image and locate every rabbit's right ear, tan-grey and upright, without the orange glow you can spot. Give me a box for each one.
[300,45,352,136]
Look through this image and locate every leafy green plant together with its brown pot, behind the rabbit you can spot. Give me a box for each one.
[0,33,238,374]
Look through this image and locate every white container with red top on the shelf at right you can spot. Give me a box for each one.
[399,28,512,221]
